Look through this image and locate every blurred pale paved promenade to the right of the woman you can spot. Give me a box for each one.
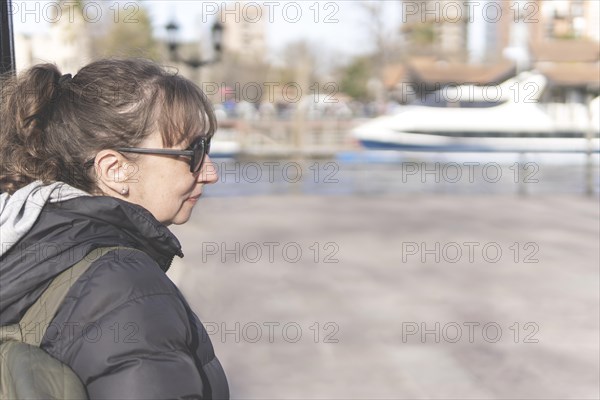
[169,193,600,399]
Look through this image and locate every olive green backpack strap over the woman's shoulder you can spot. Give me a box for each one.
[3,246,135,347]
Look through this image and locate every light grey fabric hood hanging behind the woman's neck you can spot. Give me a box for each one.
[0,181,90,257]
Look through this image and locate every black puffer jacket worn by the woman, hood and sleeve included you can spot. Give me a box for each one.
[0,196,229,399]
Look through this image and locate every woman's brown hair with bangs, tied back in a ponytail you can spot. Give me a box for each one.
[0,59,216,194]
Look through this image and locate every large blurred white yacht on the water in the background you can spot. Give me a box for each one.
[352,72,600,153]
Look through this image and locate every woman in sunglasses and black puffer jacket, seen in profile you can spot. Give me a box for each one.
[0,59,229,399]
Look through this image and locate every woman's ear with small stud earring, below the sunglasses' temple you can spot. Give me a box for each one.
[94,150,135,197]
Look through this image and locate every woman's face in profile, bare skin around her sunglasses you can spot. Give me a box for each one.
[123,133,218,225]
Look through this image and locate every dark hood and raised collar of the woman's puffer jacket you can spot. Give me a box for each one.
[0,191,183,323]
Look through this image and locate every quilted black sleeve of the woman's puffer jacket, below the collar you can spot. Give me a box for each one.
[42,253,215,399]
